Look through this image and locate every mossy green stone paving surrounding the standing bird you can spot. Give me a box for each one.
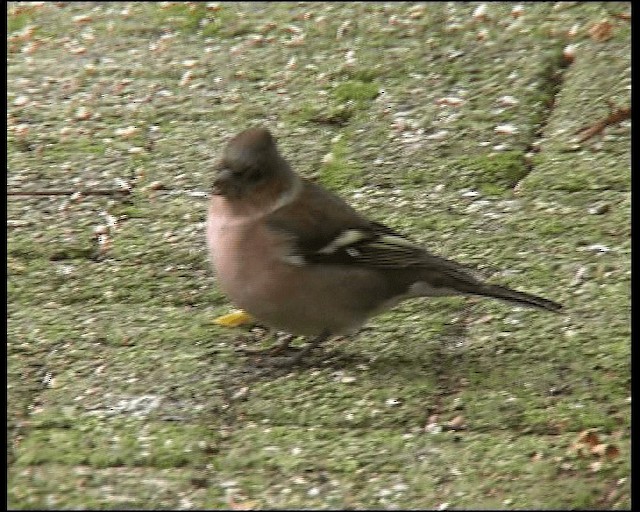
[7,2,631,510]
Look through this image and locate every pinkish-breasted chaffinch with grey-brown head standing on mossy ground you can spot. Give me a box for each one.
[207,128,562,364]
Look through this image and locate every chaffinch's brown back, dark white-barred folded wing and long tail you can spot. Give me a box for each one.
[267,183,562,312]
